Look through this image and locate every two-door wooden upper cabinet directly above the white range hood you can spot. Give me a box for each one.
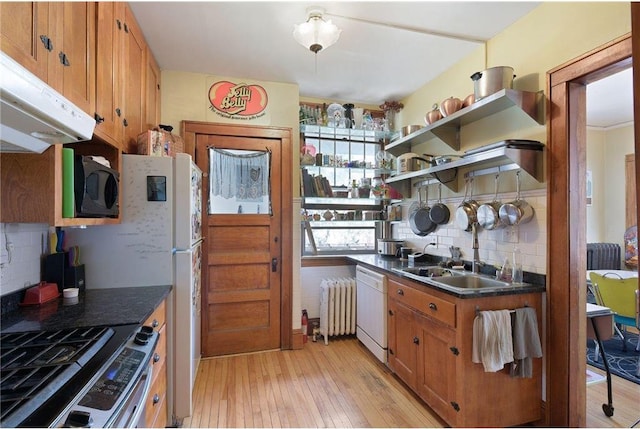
[0,2,96,114]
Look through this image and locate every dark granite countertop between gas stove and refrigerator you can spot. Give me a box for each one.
[1,285,172,333]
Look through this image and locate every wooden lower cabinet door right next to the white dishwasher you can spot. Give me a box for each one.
[387,299,418,389]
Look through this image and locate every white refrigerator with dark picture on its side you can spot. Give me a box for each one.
[66,153,203,421]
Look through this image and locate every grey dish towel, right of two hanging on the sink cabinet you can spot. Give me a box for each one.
[510,307,542,378]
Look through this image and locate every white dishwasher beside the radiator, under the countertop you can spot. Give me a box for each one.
[356,265,387,364]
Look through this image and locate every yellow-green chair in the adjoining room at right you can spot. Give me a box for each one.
[589,273,640,351]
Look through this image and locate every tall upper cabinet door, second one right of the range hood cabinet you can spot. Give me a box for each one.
[122,5,147,153]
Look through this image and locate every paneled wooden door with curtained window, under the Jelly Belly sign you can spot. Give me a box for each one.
[186,125,292,357]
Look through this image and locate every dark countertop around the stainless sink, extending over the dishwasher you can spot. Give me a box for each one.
[346,255,546,299]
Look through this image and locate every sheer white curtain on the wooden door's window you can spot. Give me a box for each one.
[209,148,271,211]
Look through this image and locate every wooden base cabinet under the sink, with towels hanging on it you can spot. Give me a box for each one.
[387,276,542,427]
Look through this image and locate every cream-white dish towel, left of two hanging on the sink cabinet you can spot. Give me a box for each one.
[471,310,513,372]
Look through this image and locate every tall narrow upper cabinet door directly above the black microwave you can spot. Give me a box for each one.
[95,2,124,148]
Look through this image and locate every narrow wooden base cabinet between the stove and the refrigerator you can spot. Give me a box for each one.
[144,301,168,428]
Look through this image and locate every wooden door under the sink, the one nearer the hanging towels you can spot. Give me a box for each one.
[416,315,461,425]
